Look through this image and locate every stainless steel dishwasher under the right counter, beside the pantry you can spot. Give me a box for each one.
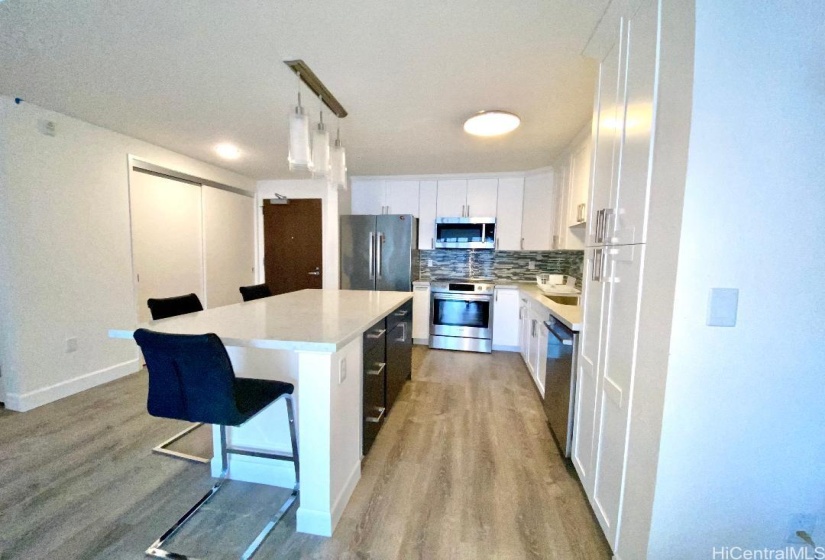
[544,317,578,457]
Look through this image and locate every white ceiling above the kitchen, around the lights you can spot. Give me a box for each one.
[0,0,607,179]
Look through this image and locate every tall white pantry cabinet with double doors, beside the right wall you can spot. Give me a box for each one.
[572,0,658,551]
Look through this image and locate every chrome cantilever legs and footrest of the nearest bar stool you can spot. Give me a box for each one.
[146,395,300,560]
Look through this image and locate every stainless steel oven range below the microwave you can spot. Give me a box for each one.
[430,282,494,352]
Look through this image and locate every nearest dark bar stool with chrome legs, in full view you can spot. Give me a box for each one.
[134,329,299,560]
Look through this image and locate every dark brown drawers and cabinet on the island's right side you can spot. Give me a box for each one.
[363,302,412,455]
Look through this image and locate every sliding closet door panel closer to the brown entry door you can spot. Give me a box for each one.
[203,186,255,307]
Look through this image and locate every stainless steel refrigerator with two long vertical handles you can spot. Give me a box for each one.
[340,214,418,292]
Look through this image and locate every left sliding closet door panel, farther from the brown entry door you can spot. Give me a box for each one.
[129,170,204,322]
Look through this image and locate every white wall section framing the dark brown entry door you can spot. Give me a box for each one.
[256,179,340,290]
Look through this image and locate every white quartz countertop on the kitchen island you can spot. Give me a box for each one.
[109,290,412,352]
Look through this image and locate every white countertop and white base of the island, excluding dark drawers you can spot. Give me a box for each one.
[109,290,412,536]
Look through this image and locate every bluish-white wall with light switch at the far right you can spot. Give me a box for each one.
[648,0,825,559]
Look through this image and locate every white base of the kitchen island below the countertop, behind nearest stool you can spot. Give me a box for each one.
[212,337,363,537]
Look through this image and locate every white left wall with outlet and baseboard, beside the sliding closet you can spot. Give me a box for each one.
[0,96,255,410]
